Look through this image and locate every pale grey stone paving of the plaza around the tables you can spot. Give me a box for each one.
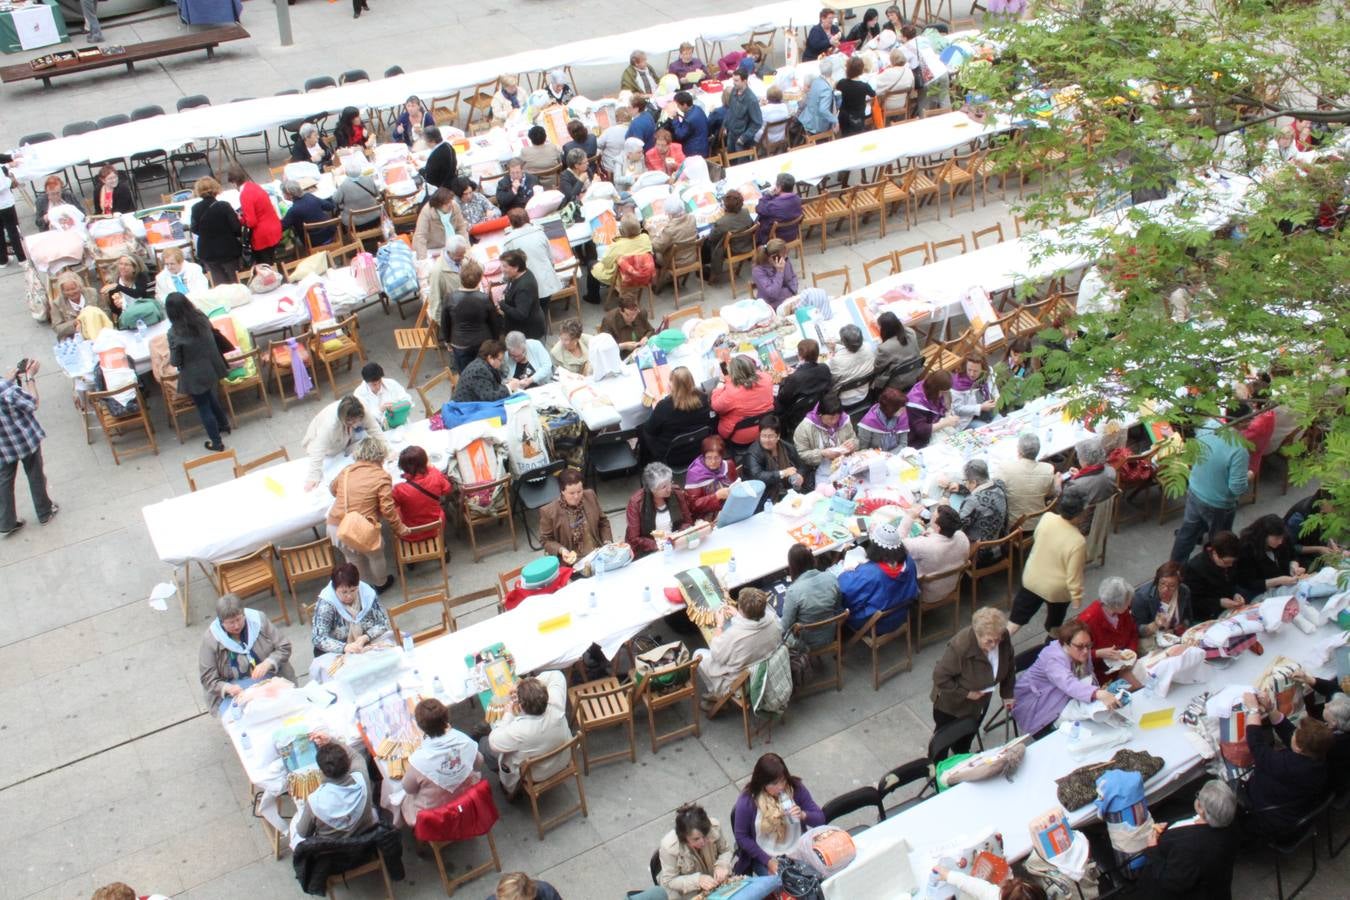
[0,0,1350,900]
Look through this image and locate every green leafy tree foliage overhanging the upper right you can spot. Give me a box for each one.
[960,0,1350,540]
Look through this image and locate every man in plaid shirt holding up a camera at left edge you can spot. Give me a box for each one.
[0,359,61,537]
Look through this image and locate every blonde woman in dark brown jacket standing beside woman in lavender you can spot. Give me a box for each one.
[930,606,1017,753]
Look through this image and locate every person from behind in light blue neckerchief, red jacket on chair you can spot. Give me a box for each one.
[398,698,483,828]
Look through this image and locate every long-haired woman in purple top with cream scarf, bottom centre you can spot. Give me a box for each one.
[732,753,825,876]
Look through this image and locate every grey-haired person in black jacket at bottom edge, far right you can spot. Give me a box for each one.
[1138,779,1238,900]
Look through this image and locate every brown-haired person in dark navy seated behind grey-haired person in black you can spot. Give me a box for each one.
[1242,692,1335,842]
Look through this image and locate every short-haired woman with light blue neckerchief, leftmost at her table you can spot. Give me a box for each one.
[197,594,296,714]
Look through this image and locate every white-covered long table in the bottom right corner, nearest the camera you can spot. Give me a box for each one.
[825,615,1334,900]
